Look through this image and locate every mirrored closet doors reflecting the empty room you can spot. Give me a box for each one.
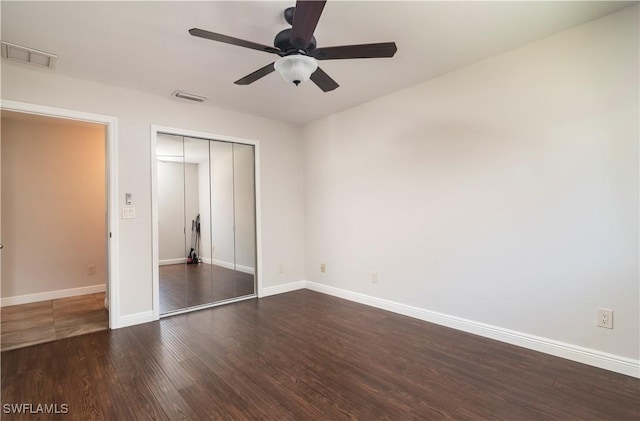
[156,134,256,315]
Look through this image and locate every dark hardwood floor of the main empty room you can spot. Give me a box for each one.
[2,290,640,420]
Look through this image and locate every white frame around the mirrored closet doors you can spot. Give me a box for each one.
[150,124,262,320]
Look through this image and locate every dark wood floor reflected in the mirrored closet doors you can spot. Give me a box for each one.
[159,263,255,314]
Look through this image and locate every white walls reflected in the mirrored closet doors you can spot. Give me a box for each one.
[165,140,256,270]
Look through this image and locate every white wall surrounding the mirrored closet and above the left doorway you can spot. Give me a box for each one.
[1,60,304,317]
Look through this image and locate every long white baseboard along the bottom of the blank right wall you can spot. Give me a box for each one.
[304,281,640,378]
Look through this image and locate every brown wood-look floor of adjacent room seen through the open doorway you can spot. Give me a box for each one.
[0,292,109,351]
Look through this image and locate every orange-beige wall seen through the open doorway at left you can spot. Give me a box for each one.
[1,113,106,299]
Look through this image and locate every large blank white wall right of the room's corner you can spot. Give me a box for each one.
[303,7,640,360]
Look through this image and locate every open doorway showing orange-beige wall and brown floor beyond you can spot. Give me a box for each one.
[0,111,108,350]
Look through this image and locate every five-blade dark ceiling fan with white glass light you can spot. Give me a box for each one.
[189,0,397,92]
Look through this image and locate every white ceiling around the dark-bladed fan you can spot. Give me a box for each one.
[0,0,637,123]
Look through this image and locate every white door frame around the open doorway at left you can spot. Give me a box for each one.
[0,99,120,329]
